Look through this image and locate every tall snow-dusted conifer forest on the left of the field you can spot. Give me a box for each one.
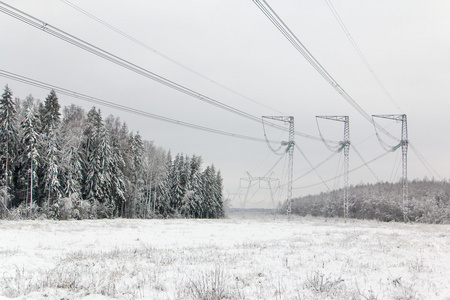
[0,86,224,219]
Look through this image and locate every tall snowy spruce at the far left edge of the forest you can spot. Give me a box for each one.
[0,85,19,211]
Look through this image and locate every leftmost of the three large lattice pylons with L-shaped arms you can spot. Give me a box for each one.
[263,116,295,215]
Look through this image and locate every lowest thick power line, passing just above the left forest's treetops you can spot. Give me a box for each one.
[0,69,275,143]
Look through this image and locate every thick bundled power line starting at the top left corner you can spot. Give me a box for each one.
[0,1,322,141]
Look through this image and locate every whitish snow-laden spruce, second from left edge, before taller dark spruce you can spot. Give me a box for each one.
[20,106,39,212]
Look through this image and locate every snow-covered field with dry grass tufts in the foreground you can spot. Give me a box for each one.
[0,214,450,299]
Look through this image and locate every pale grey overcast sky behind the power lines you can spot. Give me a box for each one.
[0,0,450,207]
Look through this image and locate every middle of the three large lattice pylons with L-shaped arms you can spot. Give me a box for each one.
[316,116,350,219]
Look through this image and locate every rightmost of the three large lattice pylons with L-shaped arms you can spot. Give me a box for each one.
[372,114,409,222]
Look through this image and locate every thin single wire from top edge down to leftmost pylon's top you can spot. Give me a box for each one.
[61,0,284,114]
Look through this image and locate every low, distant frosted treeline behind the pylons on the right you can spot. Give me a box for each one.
[292,179,450,224]
